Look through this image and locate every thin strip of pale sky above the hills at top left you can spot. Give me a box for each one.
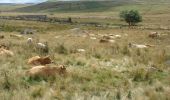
[0,0,46,3]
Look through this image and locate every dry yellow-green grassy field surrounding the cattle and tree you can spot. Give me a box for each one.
[0,1,170,100]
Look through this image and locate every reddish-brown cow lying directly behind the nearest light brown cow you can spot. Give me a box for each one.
[28,56,52,65]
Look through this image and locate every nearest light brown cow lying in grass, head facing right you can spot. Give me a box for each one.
[26,65,66,77]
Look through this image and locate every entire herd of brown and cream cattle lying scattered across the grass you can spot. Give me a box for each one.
[0,29,160,77]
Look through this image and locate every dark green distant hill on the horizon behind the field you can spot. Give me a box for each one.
[15,0,132,12]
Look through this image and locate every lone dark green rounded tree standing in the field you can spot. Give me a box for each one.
[120,10,142,26]
